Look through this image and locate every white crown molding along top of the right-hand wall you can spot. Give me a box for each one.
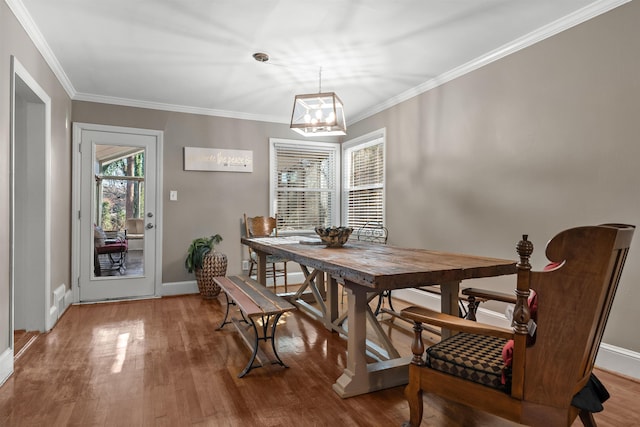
[348,0,631,125]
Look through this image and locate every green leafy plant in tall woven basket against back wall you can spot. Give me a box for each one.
[184,234,227,298]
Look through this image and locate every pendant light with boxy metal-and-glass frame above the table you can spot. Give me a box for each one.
[290,67,347,136]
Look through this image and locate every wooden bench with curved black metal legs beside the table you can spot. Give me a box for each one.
[213,276,296,378]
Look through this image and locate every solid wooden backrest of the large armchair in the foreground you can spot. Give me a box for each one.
[512,224,635,407]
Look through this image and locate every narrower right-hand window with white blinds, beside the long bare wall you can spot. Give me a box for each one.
[342,129,386,229]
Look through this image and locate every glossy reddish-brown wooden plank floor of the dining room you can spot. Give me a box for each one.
[0,295,640,427]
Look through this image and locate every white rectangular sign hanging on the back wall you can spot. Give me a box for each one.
[184,147,253,172]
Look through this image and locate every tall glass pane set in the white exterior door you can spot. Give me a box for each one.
[93,144,145,278]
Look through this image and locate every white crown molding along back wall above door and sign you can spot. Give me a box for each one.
[73,93,289,124]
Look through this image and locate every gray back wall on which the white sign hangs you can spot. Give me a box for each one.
[73,103,296,283]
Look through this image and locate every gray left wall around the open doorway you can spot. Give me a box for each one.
[0,1,71,354]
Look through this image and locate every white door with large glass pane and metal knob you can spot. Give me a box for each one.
[74,124,162,301]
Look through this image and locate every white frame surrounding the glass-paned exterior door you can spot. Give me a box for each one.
[71,122,164,303]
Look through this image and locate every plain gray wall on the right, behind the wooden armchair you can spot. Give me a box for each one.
[349,2,640,351]
